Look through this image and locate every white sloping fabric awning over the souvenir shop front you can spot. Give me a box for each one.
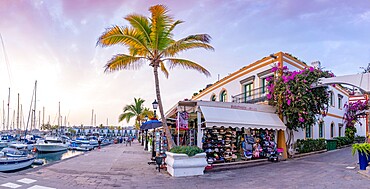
[200,106,286,130]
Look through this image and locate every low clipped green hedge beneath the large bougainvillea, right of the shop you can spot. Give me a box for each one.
[296,138,326,153]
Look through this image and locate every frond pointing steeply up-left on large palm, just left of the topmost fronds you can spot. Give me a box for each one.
[125,14,151,46]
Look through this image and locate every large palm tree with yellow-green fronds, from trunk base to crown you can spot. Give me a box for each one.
[97,5,213,148]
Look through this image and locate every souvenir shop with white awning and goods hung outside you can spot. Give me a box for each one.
[165,101,285,164]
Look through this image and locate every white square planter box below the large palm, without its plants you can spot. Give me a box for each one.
[166,152,208,177]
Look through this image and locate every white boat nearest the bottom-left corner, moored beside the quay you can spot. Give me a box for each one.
[0,157,35,172]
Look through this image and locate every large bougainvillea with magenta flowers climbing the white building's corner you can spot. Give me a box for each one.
[267,65,334,131]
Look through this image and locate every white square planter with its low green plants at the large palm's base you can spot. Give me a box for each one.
[166,146,208,177]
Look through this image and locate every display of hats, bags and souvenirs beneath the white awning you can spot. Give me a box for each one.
[203,127,277,163]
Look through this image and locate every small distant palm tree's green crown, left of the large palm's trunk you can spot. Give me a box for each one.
[118,98,153,129]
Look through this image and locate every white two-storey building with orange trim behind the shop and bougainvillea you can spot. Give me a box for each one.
[192,52,349,140]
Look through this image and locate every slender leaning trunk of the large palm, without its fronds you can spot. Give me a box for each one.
[153,64,175,150]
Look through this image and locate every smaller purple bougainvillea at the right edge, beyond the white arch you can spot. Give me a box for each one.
[343,100,369,127]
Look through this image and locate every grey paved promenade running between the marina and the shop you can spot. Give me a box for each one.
[0,144,370,189]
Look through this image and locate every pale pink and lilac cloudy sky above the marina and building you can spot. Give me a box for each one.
[0,0,370,128]
